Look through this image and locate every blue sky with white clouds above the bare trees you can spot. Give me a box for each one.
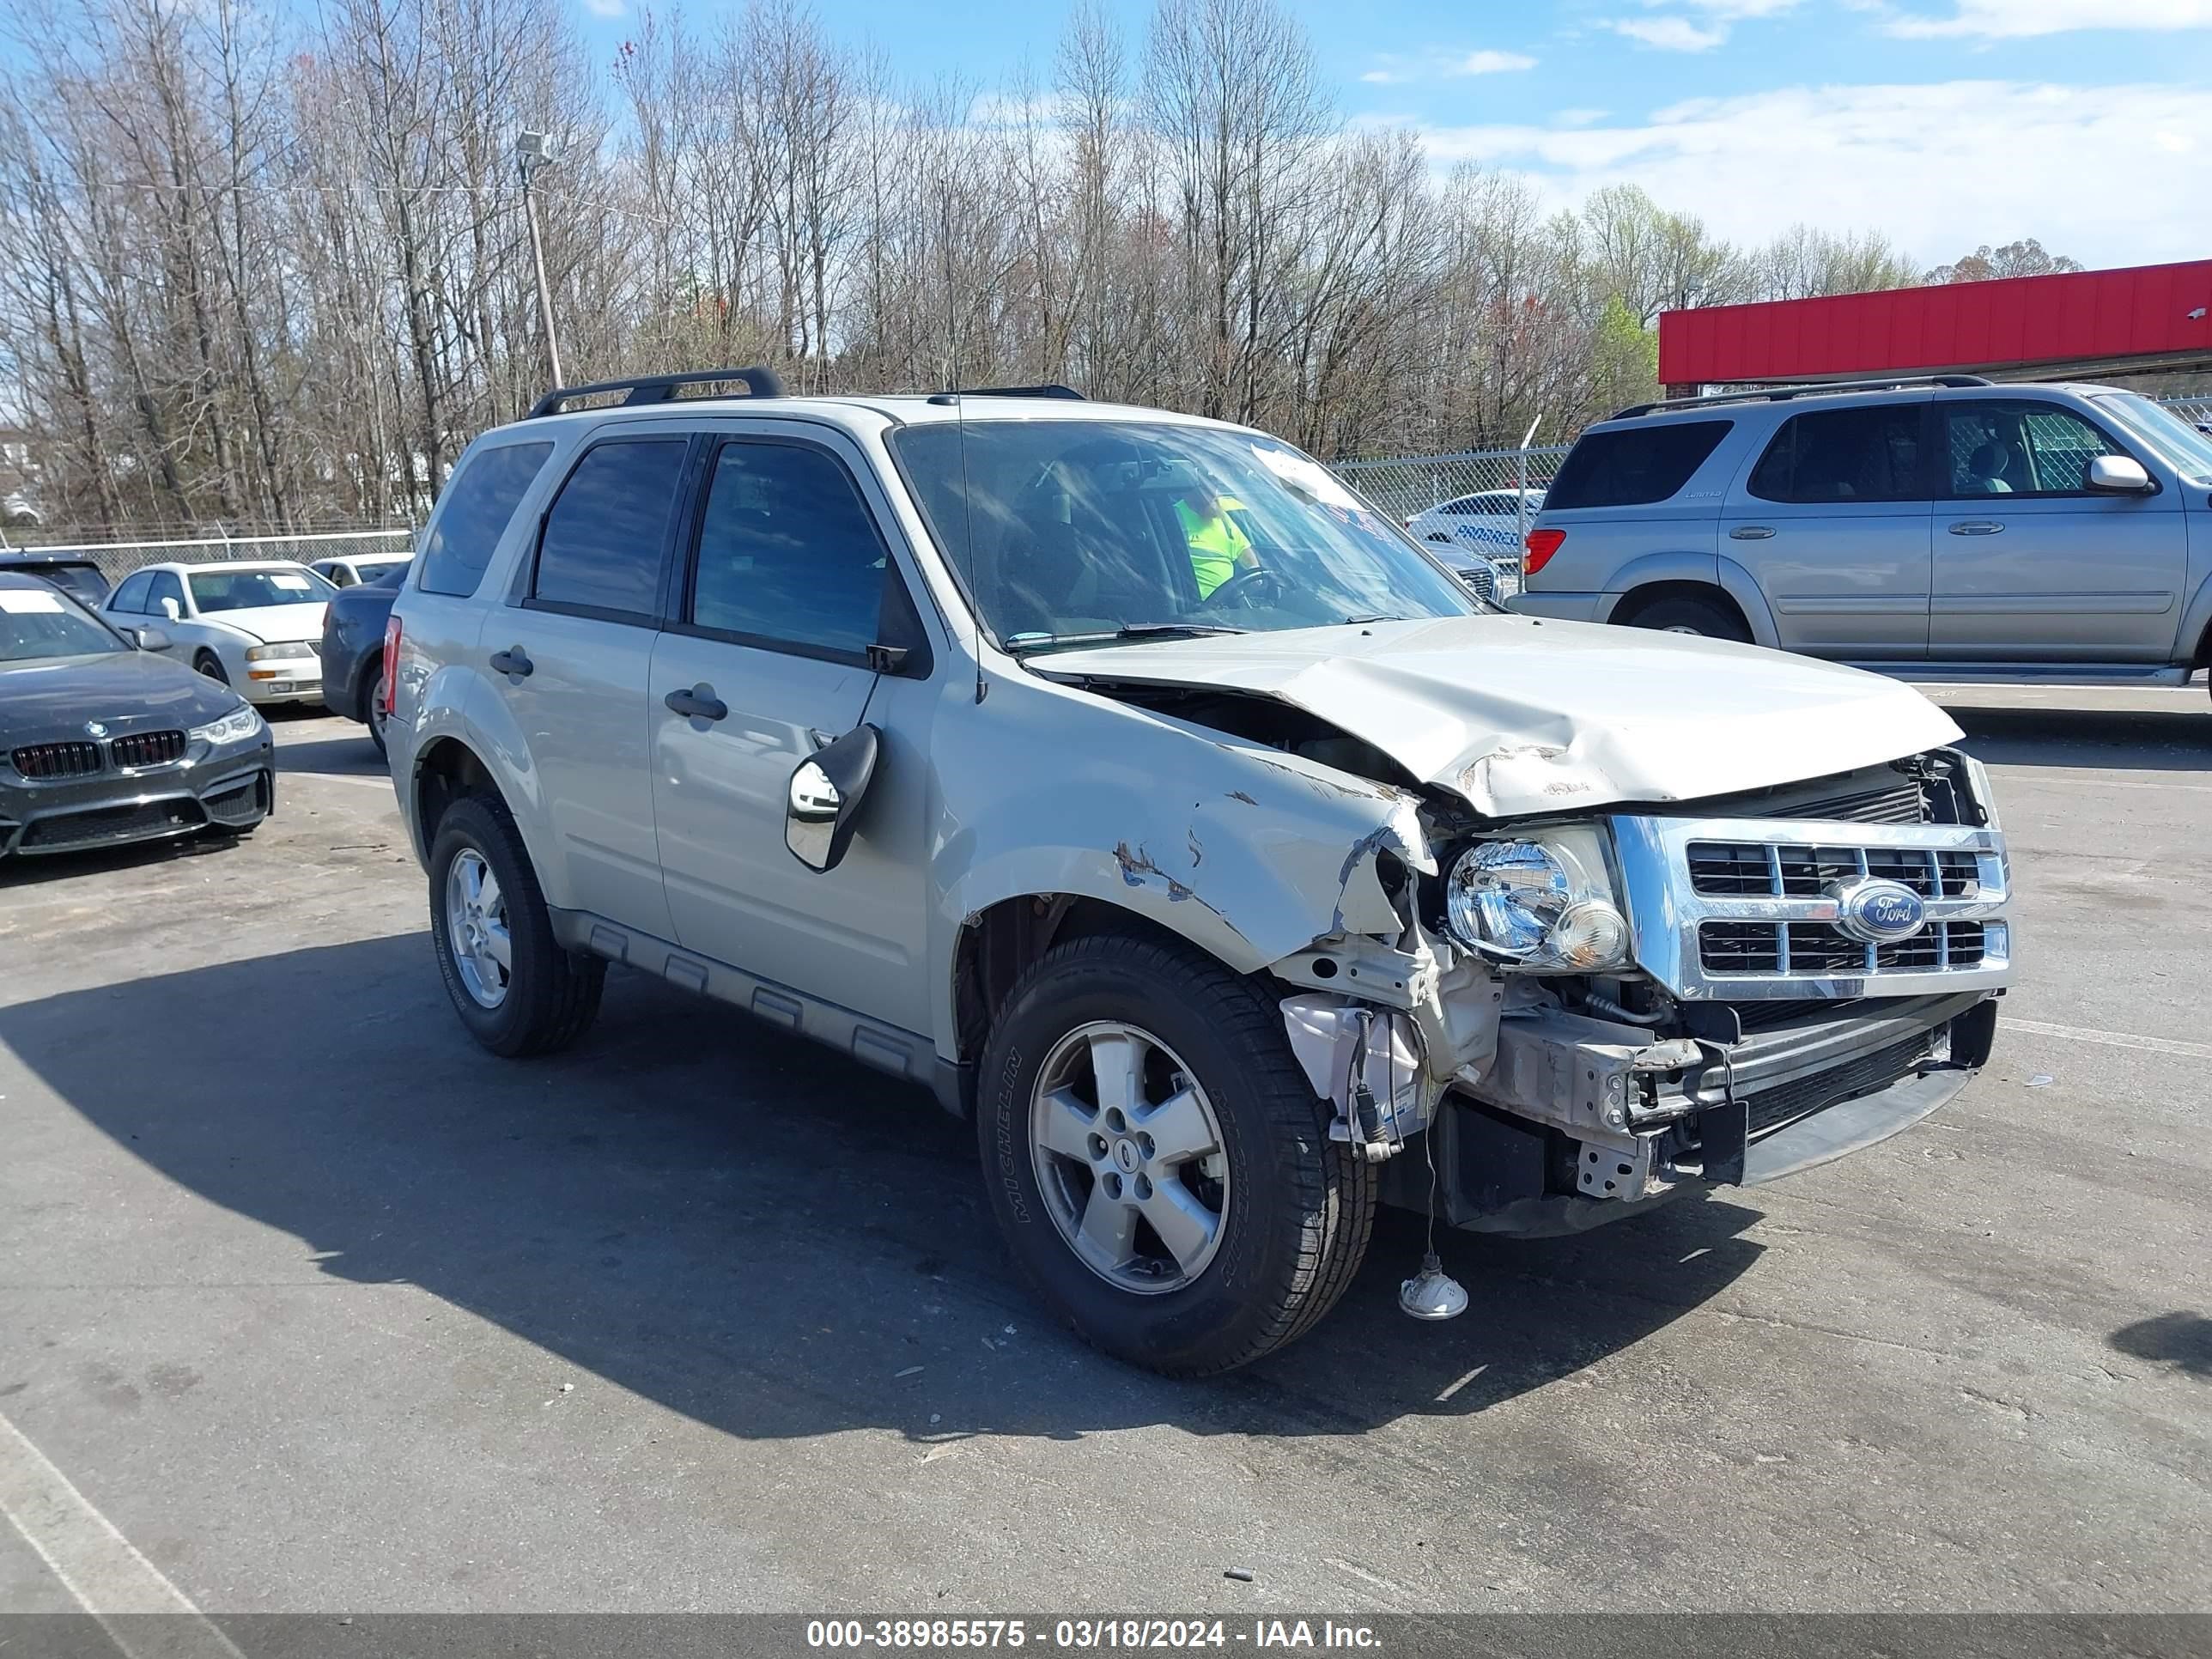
[573,0,2212,265]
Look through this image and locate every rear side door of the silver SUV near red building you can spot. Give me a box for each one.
[1721,394,1931,661]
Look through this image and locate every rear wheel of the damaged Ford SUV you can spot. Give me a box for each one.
[429,794,606,1057]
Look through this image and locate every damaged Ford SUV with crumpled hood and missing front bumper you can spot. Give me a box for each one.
[385,369,2011,1374]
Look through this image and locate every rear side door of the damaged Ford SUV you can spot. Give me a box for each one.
[477,438,690,938]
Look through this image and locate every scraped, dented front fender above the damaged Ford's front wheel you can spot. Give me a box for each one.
[931,677,1431,1055]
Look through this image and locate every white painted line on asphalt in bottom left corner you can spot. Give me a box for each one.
[0,1416,243,1659]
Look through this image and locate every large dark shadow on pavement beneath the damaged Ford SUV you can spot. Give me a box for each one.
[0,933,1760,1440]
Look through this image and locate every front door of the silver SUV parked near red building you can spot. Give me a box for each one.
[1929,396,2188,661]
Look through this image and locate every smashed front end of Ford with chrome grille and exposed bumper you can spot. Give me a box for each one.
[1270,750,2011,1234]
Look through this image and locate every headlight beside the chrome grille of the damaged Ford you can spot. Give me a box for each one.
[1444,825,1628,973]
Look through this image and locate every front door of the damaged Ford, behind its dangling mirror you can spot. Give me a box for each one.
[646,425,929,1030]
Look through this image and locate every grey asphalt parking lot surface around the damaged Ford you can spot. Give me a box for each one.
[0,686,2212,1613]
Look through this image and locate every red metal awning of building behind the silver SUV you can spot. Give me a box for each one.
[1659,258,2212,387]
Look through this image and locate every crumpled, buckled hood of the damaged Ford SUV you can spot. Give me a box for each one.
[1030,615,1960,818]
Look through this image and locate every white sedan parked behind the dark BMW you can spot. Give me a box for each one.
[101,560,337,703]
